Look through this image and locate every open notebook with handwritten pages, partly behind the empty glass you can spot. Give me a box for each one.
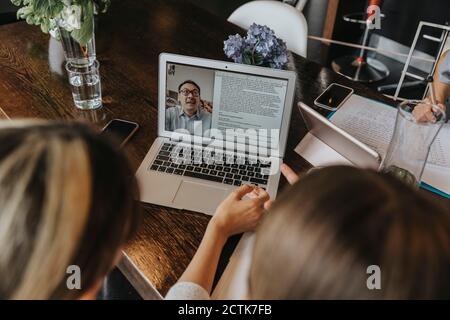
[329,95,450,197]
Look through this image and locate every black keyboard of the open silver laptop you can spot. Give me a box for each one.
[149,143,271,187]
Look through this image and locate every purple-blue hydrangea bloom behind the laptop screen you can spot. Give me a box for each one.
[224,23,288,69]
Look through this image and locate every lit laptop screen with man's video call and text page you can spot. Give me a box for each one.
[165,62,288,145]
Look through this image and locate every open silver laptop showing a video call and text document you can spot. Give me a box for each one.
[136,53,296,215]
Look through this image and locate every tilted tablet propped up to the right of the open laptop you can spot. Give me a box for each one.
[298,102,381,170]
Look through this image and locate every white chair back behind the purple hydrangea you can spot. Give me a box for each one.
[228,0,308,58]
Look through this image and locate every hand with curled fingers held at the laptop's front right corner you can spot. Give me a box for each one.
[210,185,269,238]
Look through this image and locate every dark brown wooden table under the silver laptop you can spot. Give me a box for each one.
[0,0,443,299]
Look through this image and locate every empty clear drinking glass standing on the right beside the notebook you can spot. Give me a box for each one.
[381,100,446,186]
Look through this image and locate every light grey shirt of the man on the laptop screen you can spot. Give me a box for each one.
[166,105,211,134]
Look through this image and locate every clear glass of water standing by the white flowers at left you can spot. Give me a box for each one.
[66,60,102,110]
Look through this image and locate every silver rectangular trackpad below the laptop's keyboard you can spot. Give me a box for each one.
[172,181,227,214]
